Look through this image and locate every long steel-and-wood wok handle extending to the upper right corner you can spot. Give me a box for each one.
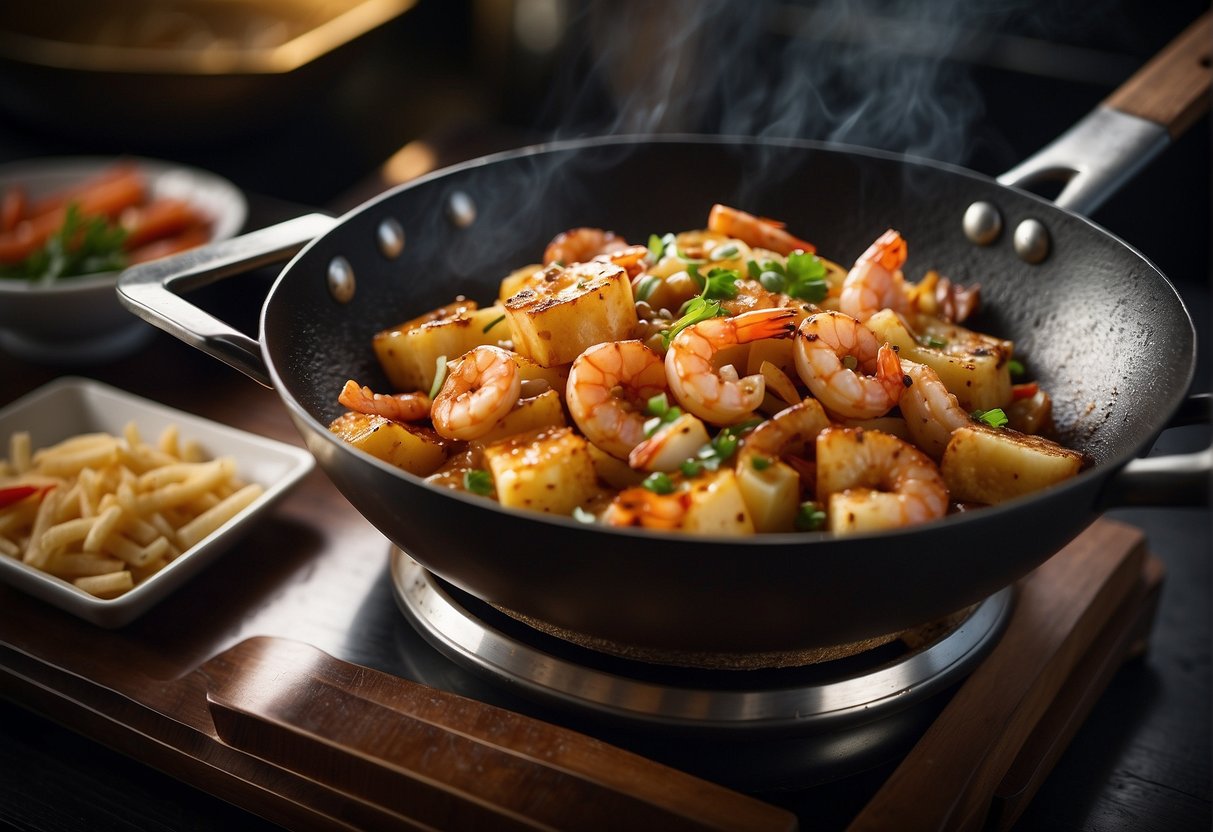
[998,12,1213,215]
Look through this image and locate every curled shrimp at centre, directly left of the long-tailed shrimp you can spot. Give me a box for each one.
[565,341,667,460]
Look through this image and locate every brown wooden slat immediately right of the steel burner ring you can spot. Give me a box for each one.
[849,520,1145,832]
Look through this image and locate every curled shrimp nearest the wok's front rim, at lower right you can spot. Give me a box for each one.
[816,427,949,534]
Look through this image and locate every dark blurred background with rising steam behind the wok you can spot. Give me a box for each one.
[0,0,1209,388]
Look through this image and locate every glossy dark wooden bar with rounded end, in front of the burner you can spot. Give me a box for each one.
[205,638,797,831]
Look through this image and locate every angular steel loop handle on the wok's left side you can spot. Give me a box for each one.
[118,213,337,387]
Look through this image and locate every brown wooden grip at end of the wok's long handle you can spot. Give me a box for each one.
[1104,12,1213,138]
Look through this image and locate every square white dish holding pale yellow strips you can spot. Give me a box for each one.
[0,377,315,628]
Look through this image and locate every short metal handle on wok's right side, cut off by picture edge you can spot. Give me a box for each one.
[1103,393,1213,508]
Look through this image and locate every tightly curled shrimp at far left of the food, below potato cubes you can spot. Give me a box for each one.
[431,344,522,439]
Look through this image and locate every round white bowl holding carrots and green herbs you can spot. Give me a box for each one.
[0,156,247,365]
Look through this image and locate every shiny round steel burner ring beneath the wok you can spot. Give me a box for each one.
[391,547,1013,736]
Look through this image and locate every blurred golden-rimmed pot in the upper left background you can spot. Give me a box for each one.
[0,0,416,142]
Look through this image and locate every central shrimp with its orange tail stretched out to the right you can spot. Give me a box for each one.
[666,309,796,424]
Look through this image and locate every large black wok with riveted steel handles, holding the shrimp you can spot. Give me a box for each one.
[119,14,1209,653]
